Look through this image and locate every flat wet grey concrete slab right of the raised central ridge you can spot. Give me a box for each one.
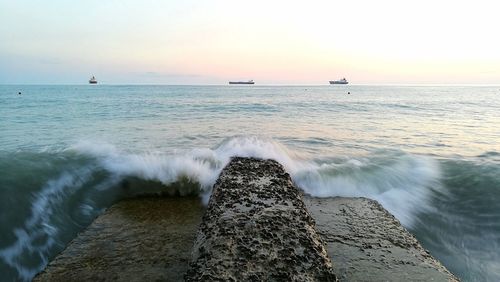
[304,197,458,281]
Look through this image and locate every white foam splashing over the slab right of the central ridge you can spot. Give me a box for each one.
[292,154,440,227]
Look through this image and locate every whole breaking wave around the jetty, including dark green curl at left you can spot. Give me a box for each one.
[0,136,446,280]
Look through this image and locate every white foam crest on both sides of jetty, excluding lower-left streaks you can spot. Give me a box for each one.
[72,136,440,226]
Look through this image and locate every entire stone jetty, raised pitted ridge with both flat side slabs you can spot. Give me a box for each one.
[34,157,457,281]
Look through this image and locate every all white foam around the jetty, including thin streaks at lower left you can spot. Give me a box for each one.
[0,136,440,280]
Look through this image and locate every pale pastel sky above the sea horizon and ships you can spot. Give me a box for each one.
[0,0,500,84]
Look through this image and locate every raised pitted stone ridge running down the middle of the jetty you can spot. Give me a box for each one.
[185,158,336,281]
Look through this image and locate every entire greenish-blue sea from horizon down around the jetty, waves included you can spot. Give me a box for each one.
[0,85,500,281]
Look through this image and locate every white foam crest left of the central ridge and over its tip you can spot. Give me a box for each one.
[71,137,301,196]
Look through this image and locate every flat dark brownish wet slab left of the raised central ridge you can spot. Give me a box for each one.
[34,197,203,281]
